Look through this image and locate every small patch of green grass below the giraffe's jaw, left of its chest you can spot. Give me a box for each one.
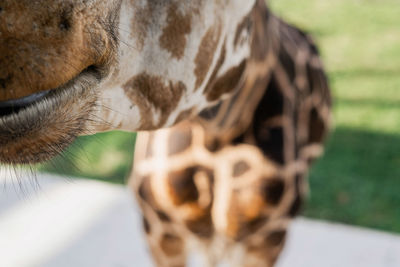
[39,131,135,184]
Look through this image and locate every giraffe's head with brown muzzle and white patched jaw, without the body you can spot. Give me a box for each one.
[0,0,256,164]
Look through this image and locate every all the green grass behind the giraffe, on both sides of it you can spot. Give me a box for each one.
[44,0,400,232]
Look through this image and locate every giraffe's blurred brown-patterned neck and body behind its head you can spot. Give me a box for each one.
[130,3,331,266]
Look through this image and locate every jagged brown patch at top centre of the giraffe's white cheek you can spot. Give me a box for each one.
[160,3,192,59]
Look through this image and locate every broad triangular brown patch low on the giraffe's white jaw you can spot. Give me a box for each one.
[123,73,186,130]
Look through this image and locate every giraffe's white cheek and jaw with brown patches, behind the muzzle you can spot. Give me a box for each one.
[93,0,262,131]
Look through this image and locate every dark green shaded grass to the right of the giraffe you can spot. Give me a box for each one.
[305,128,400,232]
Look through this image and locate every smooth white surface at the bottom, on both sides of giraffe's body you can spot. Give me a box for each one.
[0,172,400,267]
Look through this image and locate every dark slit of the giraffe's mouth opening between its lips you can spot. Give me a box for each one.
[0,91,49,117]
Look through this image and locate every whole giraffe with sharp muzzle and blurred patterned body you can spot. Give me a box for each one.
[0,0,330,266]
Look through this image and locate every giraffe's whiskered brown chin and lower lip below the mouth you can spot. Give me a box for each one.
[0,70,100,165]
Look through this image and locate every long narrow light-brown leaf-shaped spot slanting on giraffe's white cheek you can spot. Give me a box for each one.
[194,24,221,89]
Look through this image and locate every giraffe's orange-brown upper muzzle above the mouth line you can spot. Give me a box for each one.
[0,0,116,102]
